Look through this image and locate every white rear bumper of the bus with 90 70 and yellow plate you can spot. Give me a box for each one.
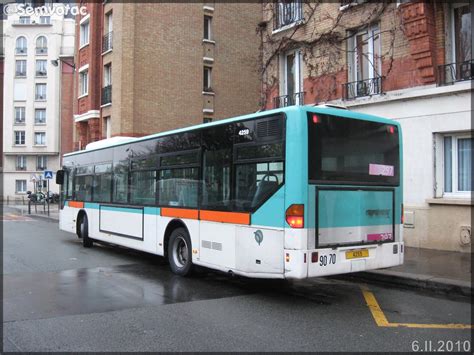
[284,242,404,279]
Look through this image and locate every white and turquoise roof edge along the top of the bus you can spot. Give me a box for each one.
[64,105,399,157]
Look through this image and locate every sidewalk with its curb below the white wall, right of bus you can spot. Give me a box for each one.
[352,247,472,296]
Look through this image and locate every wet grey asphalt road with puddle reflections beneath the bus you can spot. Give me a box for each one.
[3,208,471,351]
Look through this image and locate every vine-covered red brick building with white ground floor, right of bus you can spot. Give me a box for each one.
[259,0,474,252]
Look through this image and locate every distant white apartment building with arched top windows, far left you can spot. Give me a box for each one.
[2,1,75,199]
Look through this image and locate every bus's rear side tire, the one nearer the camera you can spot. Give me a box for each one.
[168,228,193,276]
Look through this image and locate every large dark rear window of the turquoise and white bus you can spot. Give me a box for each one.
[308,113,400,186]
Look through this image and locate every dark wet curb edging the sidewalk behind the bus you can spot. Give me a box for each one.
[338,270,472,297]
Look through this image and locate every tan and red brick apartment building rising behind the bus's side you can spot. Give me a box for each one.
[74,2,261,149]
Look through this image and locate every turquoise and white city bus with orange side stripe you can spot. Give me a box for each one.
[56,106,404,279]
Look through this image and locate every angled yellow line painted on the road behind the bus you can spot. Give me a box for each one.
[360,285,474,329]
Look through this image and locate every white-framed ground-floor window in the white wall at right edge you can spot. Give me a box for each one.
[443,134,474,196]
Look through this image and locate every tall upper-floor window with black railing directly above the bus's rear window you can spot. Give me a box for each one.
[344,25,382,99]
